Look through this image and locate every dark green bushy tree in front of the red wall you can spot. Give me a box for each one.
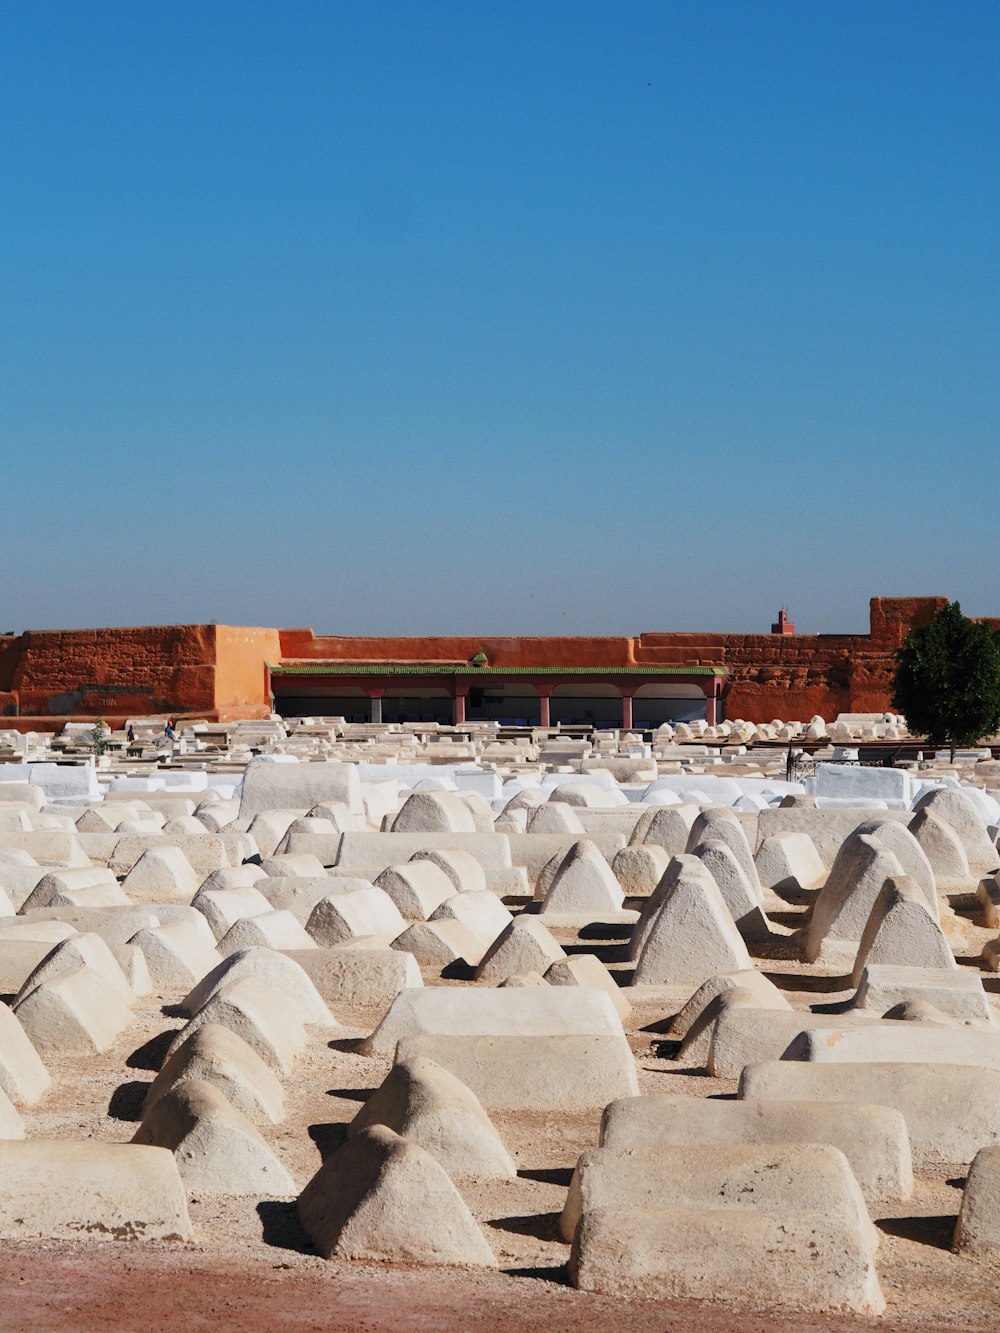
[892,601,1000,758]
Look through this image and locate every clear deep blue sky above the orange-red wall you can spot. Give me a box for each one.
[0,0,1000,633]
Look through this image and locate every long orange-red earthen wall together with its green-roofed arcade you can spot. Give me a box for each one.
[0,597,965,730]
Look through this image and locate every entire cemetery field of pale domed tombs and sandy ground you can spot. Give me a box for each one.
[0,718,1000,1333]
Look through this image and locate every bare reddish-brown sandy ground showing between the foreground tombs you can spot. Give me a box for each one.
[0,885,1000,1333]
